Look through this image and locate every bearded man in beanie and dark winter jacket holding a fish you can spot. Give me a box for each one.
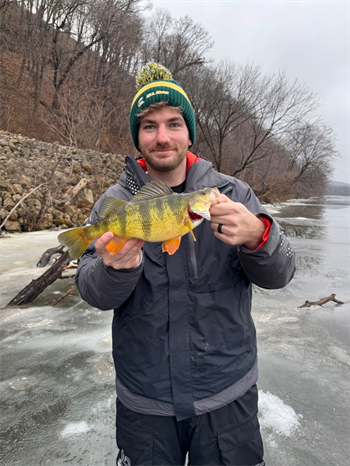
[76,63,294,466]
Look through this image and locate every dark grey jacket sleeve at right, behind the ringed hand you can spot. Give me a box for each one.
[238,188,295,289]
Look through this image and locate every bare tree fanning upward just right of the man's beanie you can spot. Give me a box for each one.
[187,61,264,170]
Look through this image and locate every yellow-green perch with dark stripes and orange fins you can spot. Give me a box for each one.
[58,181,220,259]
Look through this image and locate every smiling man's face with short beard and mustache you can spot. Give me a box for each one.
[139,107,192,172]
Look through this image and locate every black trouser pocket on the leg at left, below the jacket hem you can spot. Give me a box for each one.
[117,416,153,466]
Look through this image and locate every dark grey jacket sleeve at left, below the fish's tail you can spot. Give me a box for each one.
[75,195,143,310]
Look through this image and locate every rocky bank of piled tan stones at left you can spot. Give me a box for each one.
[0,131,125,233]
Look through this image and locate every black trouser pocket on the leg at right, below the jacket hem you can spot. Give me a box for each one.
[218,414,265,466]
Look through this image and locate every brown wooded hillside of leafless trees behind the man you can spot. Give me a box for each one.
[0,0,336,206]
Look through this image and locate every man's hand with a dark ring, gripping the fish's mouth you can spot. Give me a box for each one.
[210,194,266,250]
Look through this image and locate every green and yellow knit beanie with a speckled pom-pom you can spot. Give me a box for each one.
[130,62,196,149]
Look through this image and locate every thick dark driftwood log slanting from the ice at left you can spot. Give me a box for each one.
[7,251,71,306]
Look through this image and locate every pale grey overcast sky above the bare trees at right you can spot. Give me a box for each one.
[147,0,350,183]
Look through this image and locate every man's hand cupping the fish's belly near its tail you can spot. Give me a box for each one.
[95,231,144,270]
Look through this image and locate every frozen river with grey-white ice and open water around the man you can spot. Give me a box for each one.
[0,197,350,466]
